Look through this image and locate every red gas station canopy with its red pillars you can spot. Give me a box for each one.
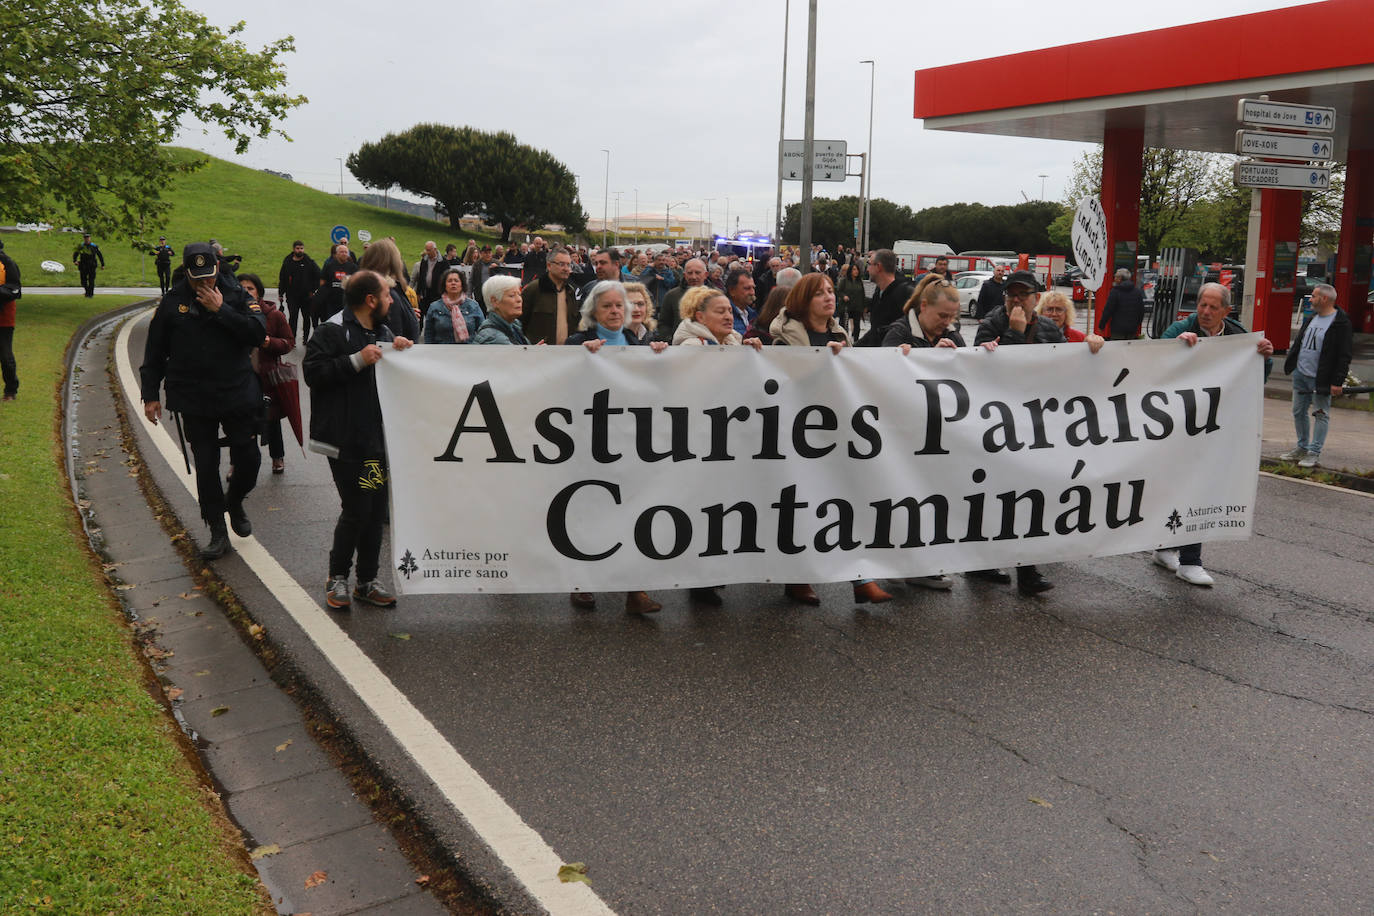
[914,0,1374,336]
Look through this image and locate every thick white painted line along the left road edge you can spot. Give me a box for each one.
[115,309,613,916]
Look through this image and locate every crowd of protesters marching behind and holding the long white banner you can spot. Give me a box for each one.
[139,229,1272,614]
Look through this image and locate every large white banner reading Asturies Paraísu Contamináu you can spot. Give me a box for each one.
[378,335,1263,593]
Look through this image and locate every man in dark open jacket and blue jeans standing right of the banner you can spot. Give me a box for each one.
[1279,283,1355,467]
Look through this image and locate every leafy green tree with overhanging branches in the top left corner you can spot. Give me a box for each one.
[0,0,305,246]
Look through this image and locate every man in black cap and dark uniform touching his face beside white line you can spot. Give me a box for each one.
[139,242,267,559]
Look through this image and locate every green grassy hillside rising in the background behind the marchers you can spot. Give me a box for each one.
[3,150,499,288]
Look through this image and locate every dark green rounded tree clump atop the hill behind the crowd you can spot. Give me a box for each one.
[348,124,587,242]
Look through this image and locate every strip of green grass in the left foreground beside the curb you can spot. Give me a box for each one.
[0,295,271,916]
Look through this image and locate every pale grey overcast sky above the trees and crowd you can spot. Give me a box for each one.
[179,0,1303,240]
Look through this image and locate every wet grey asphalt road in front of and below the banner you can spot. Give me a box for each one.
[118,311,1374,913]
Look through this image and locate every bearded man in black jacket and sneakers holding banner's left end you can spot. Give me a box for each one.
[304,271,412,610]
